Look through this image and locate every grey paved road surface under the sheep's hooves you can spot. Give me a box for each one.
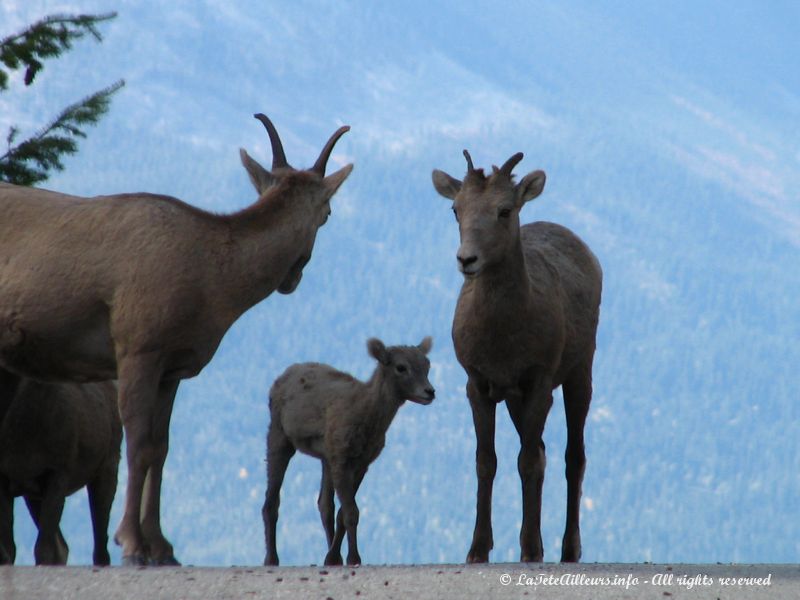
[0,563,800,600]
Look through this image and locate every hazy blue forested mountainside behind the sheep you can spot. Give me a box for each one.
[0,0,800,565]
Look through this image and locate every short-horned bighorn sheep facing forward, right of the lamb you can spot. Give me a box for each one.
[433,150,602,563]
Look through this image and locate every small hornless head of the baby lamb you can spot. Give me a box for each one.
[367,337,436,404]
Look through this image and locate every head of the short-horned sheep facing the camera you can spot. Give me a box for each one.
[433,150,545,278]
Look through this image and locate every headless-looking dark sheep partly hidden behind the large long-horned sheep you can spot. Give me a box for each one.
[0,369,122,565]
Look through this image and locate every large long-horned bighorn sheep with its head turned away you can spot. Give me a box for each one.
[0,114,353,565]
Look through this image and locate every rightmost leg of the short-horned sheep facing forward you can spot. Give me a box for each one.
[561,360,592,562]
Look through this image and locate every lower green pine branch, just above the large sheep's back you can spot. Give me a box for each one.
[0,80,125,185]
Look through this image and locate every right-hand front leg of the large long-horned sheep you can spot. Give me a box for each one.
[142,379,180,566]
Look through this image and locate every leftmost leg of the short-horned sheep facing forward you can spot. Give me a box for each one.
[467,376,497,563]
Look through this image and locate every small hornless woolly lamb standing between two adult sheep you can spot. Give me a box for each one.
[262,337,434,565]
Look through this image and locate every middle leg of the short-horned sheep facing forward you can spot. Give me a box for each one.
[506,376,553,562]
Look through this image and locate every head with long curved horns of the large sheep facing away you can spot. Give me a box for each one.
[239,113,353,294]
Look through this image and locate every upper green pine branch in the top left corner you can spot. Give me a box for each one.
[0,12,117,90]
